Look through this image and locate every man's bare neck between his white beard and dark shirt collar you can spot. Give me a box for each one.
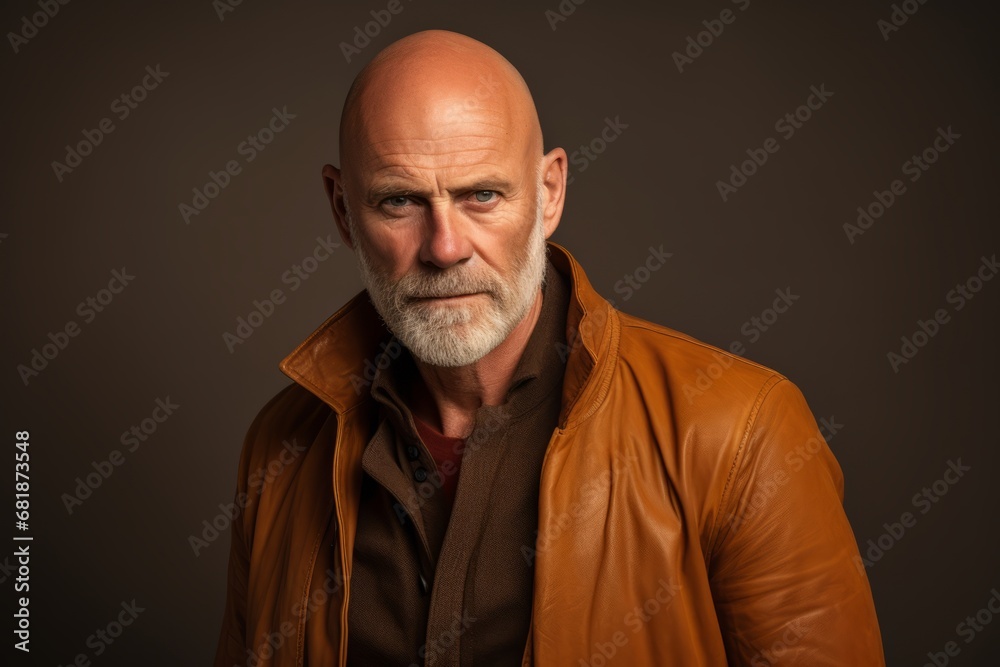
[410,289,542,438]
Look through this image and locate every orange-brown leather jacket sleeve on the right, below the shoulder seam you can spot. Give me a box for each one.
[708,376,885,667]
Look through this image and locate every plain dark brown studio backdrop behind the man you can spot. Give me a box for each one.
[0,0,1000,665]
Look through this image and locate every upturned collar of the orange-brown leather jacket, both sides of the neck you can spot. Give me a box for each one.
[279,241,618,427]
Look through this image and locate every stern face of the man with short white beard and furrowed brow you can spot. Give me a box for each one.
[344,89,546,366]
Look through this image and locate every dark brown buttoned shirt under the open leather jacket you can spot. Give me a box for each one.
[342,262,569,667]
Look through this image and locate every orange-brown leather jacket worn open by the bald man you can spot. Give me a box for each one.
[215,243,885,667]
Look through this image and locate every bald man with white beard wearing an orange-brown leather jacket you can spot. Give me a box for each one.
[216,31,884,667]
